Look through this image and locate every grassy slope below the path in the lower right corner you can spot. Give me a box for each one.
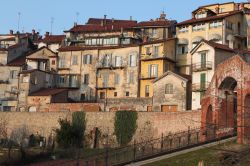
[145,142,250,166]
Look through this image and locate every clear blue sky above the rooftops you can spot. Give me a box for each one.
[0,0,243,35]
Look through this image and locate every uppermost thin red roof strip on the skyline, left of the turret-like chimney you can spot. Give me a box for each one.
[87,18,137,25]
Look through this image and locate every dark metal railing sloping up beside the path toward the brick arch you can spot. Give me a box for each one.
[83,128,235,166]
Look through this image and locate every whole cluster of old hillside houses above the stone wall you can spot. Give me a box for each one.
[0,2,250,112]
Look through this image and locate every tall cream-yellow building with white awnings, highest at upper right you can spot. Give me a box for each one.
[176,2,249,75]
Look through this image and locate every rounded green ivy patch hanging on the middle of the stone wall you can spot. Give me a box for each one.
[115,111,138,146]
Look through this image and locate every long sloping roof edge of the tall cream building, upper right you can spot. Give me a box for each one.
[177,11,242,26]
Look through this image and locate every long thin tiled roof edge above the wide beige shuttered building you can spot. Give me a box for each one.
[58,44,138,52]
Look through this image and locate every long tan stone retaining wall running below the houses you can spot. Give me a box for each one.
[0,111,201,146]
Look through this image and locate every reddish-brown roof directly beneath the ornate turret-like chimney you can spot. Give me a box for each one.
[135,20,177,27]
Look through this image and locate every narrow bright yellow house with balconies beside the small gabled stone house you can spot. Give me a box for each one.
[139,38,176,97]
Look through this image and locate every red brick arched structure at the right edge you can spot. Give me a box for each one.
[201,55,250,143]
